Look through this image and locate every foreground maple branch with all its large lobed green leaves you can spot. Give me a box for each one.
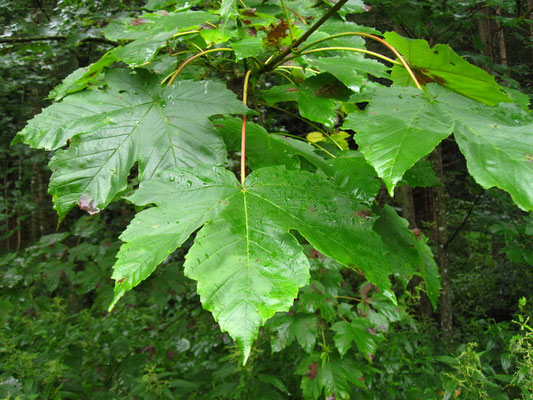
[14,0,533,372]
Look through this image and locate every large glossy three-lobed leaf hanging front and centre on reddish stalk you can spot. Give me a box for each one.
[113,166,390,360]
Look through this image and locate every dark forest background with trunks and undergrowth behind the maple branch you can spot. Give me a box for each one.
[0,0,533,399]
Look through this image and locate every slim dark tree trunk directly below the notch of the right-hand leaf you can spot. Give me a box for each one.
[431,146,453,340]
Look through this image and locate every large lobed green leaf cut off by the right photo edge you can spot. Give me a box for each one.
[344,83,533,211]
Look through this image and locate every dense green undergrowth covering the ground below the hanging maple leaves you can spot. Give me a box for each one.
[0,216,533,400]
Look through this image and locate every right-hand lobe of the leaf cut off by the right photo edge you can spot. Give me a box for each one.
[428,84,533,211]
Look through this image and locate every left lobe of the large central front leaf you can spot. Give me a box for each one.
[110,167,239,308]
